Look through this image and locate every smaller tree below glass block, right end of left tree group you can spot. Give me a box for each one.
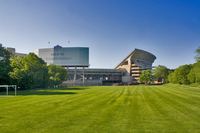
[48,65,67,86]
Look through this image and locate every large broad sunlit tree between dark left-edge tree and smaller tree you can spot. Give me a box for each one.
[10,53,48,89]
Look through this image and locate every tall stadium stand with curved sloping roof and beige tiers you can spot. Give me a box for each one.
[115,49,156,83]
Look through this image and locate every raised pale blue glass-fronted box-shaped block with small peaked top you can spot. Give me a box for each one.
[38,45,89,67]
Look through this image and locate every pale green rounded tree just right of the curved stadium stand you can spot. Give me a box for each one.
[153,65,169,83]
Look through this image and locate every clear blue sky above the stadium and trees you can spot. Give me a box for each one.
[0,0,200,68]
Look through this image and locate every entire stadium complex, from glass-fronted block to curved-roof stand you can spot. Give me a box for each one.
[38,45,156,85]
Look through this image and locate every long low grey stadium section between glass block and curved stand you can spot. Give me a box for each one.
[65,68,123,85]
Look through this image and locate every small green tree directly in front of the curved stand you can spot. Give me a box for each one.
[140,70,153,84]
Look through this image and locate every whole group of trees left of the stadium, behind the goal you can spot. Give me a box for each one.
[0,47,67,89]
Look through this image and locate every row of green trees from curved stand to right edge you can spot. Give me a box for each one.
[140,47,200,84]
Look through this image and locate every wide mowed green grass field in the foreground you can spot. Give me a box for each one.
[0,84,200,133]
